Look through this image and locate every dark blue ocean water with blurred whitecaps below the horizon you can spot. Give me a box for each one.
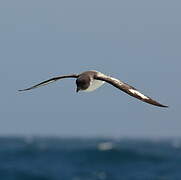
[0,137,181,180]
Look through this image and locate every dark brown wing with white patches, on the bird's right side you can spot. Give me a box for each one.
[94,73,168,107]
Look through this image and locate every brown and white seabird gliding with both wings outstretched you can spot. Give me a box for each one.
[19,71,168,107]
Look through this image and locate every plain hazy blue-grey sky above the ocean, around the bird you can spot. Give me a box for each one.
[0,0,181,137]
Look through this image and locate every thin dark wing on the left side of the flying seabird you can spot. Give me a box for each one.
[19,74,79,91]
